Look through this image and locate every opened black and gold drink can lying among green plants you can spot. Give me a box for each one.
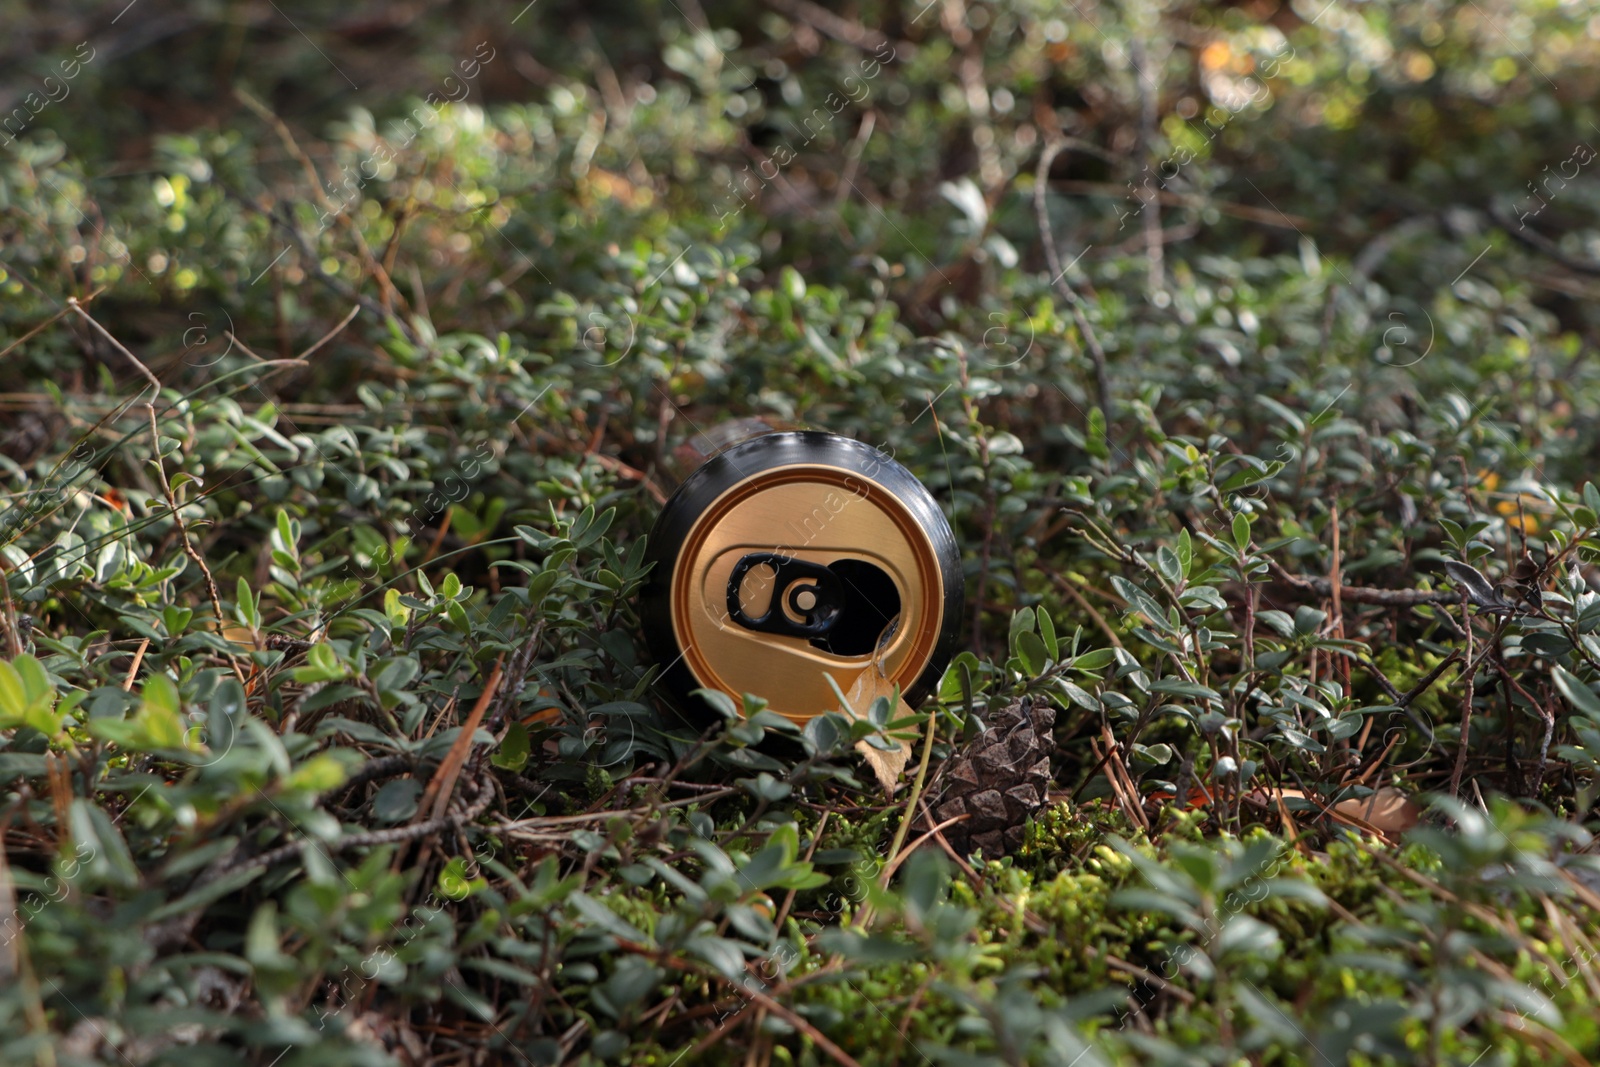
[642,421,963,721]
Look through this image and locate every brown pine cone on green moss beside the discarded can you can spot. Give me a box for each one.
[933,696,1056,859]
